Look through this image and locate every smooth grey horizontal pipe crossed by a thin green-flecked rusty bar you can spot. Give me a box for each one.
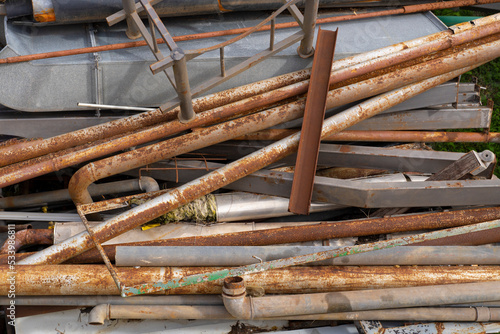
[115,246,500,267]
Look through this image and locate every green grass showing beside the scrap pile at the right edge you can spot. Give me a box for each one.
[432,9,500,177]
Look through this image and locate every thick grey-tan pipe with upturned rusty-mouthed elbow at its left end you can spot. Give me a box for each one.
[222,277,500,319]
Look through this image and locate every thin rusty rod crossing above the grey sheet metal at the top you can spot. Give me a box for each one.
[0,0,497,64]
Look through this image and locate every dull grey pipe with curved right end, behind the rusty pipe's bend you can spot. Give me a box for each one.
[0,176,160,209]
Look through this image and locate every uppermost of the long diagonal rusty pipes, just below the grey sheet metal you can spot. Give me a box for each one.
[0,16,498,170]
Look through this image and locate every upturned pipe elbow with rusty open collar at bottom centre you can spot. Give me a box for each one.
[222,277,254,320]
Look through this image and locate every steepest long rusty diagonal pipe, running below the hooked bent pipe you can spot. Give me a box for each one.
[20,65,484,264]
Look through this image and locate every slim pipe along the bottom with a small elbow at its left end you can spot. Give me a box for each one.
[89,304,500,325]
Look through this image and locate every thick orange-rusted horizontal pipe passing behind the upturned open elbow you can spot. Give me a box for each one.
[0,265,500,296]
